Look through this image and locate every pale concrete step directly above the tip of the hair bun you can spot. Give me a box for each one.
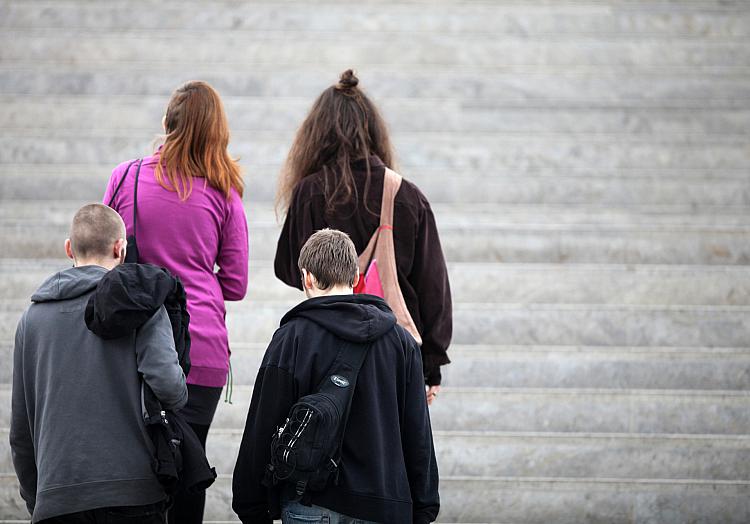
[5,31,750,71]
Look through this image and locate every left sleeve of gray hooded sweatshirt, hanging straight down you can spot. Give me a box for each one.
[10,315,37,513]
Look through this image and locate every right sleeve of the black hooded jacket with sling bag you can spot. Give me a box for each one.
[402,337,440,524]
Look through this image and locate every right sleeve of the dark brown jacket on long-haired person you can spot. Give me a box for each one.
[408,195,453,386]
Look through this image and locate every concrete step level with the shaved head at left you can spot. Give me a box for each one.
[0,201,750,265]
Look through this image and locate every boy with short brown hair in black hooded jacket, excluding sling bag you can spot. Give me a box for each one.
[232,229,440,524]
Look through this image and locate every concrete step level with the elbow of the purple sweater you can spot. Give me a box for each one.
[5,258,750,306]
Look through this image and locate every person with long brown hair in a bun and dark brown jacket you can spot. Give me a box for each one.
[274,69,453,403]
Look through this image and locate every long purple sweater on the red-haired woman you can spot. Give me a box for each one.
[104,156,248,387]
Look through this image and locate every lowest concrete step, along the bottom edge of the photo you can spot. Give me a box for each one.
[0,475,750,524]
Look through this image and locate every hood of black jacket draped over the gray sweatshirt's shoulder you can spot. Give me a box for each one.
[85,264,175,339]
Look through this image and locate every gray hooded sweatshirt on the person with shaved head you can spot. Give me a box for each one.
[10,266,187,522]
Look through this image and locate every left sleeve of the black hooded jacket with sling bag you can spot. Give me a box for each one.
[232,360,296,524]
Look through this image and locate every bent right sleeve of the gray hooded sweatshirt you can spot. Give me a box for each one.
[135,306,187,409]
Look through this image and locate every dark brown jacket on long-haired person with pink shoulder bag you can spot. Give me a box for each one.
[274,157,453,385]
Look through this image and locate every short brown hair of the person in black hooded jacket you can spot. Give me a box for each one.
[297,229,358,290]
